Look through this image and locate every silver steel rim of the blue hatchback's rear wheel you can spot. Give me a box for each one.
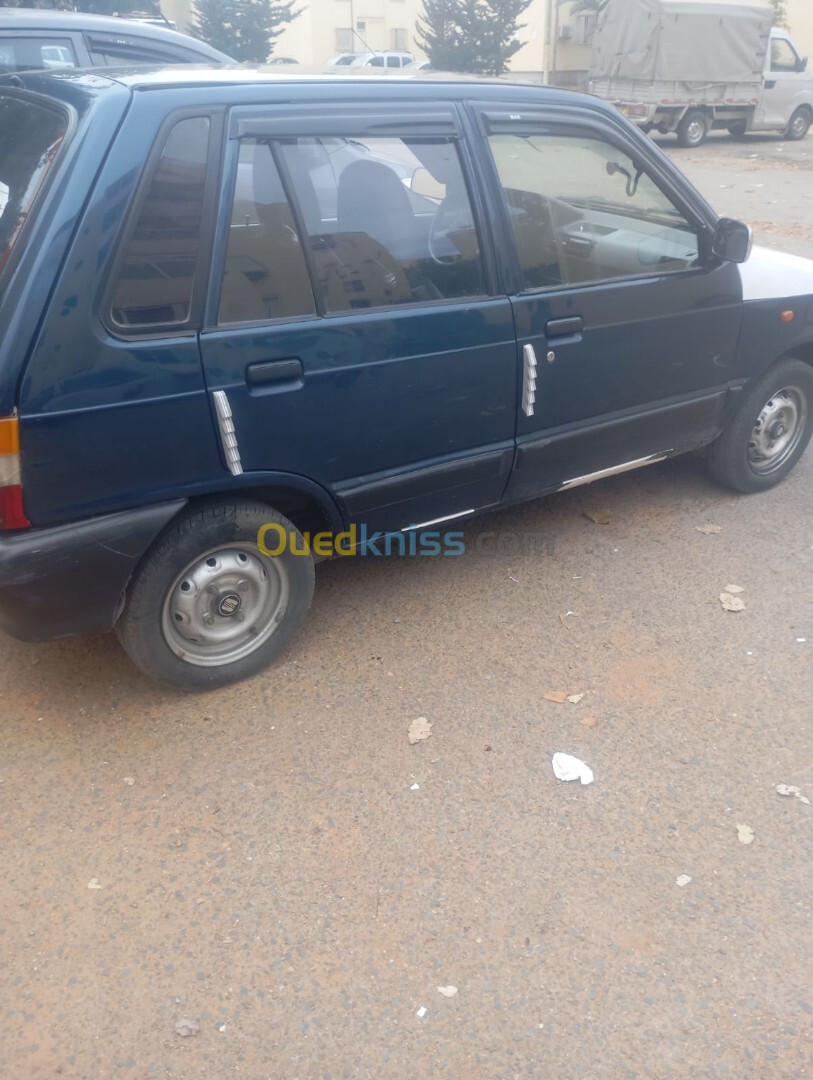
[161,543,290,667]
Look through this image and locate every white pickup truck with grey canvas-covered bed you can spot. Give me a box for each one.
[590,0,813,147]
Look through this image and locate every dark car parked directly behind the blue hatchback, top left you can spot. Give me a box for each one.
[0,8,233,75]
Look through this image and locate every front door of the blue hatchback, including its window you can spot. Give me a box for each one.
[476,106,742,499]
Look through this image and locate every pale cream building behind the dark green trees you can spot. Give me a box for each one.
[161,0,591,85]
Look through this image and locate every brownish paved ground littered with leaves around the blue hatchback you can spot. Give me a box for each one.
[0,137,813,1080]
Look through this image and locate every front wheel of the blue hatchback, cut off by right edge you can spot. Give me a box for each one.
[708,360,813,495]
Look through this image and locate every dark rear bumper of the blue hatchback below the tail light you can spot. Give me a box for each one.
[0,499,186,642]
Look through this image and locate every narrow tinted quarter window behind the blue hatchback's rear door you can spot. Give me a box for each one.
[111,117,209,328]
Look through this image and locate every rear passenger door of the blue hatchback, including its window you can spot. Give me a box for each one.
[201,103,517,529]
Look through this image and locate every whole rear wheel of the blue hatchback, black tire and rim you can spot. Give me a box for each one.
[116,501,314,690]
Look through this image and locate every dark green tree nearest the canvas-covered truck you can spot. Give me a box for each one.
[416,0,530,76]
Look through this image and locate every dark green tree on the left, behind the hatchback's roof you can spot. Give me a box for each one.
[192,0,299,64]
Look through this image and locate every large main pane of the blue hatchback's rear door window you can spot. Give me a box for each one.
[275,137,484,312]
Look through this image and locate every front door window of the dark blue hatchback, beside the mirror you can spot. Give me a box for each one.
[489,134,699,289]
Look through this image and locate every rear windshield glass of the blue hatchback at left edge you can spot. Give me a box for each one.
[0,95,67,271]
